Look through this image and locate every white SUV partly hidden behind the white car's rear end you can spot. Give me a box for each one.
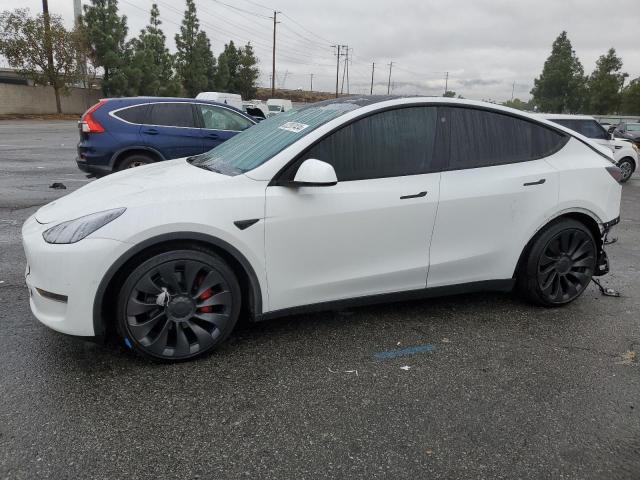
[540,114,638,183]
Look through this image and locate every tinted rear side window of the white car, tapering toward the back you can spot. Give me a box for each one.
[443,107,568,170]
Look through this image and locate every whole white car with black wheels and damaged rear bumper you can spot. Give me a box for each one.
[22,97,621,360]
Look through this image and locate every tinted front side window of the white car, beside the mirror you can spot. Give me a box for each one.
[304,107,444,182]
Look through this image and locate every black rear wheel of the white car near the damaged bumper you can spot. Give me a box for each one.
[517,219,597,307]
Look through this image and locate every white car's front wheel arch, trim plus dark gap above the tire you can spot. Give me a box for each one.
[93,232,262,339]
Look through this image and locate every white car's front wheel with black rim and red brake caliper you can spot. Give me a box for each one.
[116,249,241,362]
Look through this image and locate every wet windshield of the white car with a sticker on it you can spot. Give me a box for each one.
[189,102,359,175]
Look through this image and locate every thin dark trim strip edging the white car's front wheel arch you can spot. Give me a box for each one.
[93,232,262,338]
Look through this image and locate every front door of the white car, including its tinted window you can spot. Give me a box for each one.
[265,107,442,310]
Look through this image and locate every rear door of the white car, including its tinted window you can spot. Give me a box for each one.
[427,107,568,287]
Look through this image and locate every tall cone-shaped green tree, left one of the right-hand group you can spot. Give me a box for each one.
[531,31,585,113]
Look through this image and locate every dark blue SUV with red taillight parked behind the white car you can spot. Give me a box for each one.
[76,97,256,176]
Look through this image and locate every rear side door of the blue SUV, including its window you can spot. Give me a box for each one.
[140,102,202,159]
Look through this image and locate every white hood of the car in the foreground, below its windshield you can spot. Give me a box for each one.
[35,158,231,224]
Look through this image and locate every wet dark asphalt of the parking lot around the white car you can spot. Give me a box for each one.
[0,121,640,479]
